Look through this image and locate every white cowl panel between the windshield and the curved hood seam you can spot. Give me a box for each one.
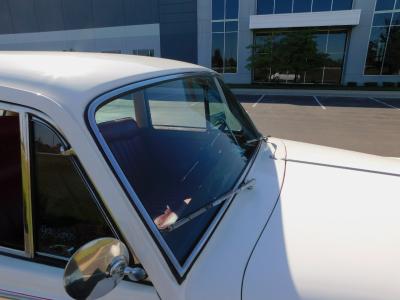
[182,139,285,300]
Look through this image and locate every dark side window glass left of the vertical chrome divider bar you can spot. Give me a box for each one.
[0,111,24,250]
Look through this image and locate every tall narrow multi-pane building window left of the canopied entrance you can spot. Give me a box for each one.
[211,0,239,73]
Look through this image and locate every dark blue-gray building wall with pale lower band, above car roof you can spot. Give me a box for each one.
[0,0,197,63]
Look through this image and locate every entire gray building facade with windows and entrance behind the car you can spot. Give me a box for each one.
[0,0,400,85]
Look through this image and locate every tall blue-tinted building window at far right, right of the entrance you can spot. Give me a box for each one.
[364,0,400,75]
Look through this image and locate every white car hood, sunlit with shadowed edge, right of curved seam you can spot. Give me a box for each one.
[243,141,400,300]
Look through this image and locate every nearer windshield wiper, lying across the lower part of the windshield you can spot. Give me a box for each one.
[165,178,256,232]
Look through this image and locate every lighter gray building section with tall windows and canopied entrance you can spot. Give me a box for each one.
[197,0,400,85]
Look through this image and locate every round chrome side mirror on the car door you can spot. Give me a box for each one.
[64,238,147,299]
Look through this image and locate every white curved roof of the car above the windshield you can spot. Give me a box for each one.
[0,51,210,113]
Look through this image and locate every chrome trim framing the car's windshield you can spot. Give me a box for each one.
[86,71,261,278]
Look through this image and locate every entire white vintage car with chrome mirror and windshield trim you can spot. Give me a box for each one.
[0,52,400,300]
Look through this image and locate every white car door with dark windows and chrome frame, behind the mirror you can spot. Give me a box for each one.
[0,103,159,299]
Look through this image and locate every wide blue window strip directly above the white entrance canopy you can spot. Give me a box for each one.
[257,0,353,15]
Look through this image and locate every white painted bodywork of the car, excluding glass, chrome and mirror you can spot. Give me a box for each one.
[0,52,400,300]
